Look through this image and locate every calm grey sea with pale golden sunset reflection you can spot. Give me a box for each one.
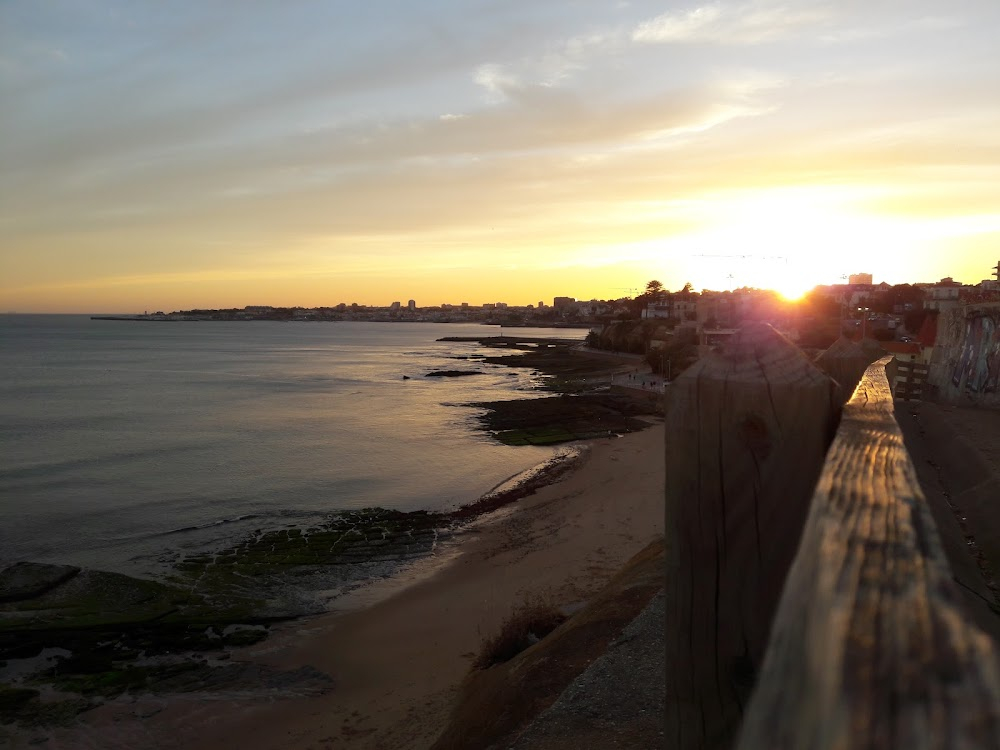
[0,315,584,572]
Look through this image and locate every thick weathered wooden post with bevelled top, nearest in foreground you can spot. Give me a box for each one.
[665,324,838,750]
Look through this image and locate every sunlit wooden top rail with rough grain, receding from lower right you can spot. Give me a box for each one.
[738,357,1000,750]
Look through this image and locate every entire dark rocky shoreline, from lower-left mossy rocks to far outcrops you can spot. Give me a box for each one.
[0,337,649,739]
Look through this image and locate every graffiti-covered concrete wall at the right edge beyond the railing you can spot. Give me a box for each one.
[928,302,1000,406]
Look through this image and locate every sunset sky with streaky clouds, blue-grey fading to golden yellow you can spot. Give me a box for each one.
[0,0,1000,312]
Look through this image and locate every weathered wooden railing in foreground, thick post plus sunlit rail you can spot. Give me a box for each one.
[665,326,1000,750]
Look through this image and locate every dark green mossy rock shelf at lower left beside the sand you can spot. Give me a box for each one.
[0,508,458,726]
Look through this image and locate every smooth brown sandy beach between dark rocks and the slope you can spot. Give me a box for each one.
[24,418,663,750]
